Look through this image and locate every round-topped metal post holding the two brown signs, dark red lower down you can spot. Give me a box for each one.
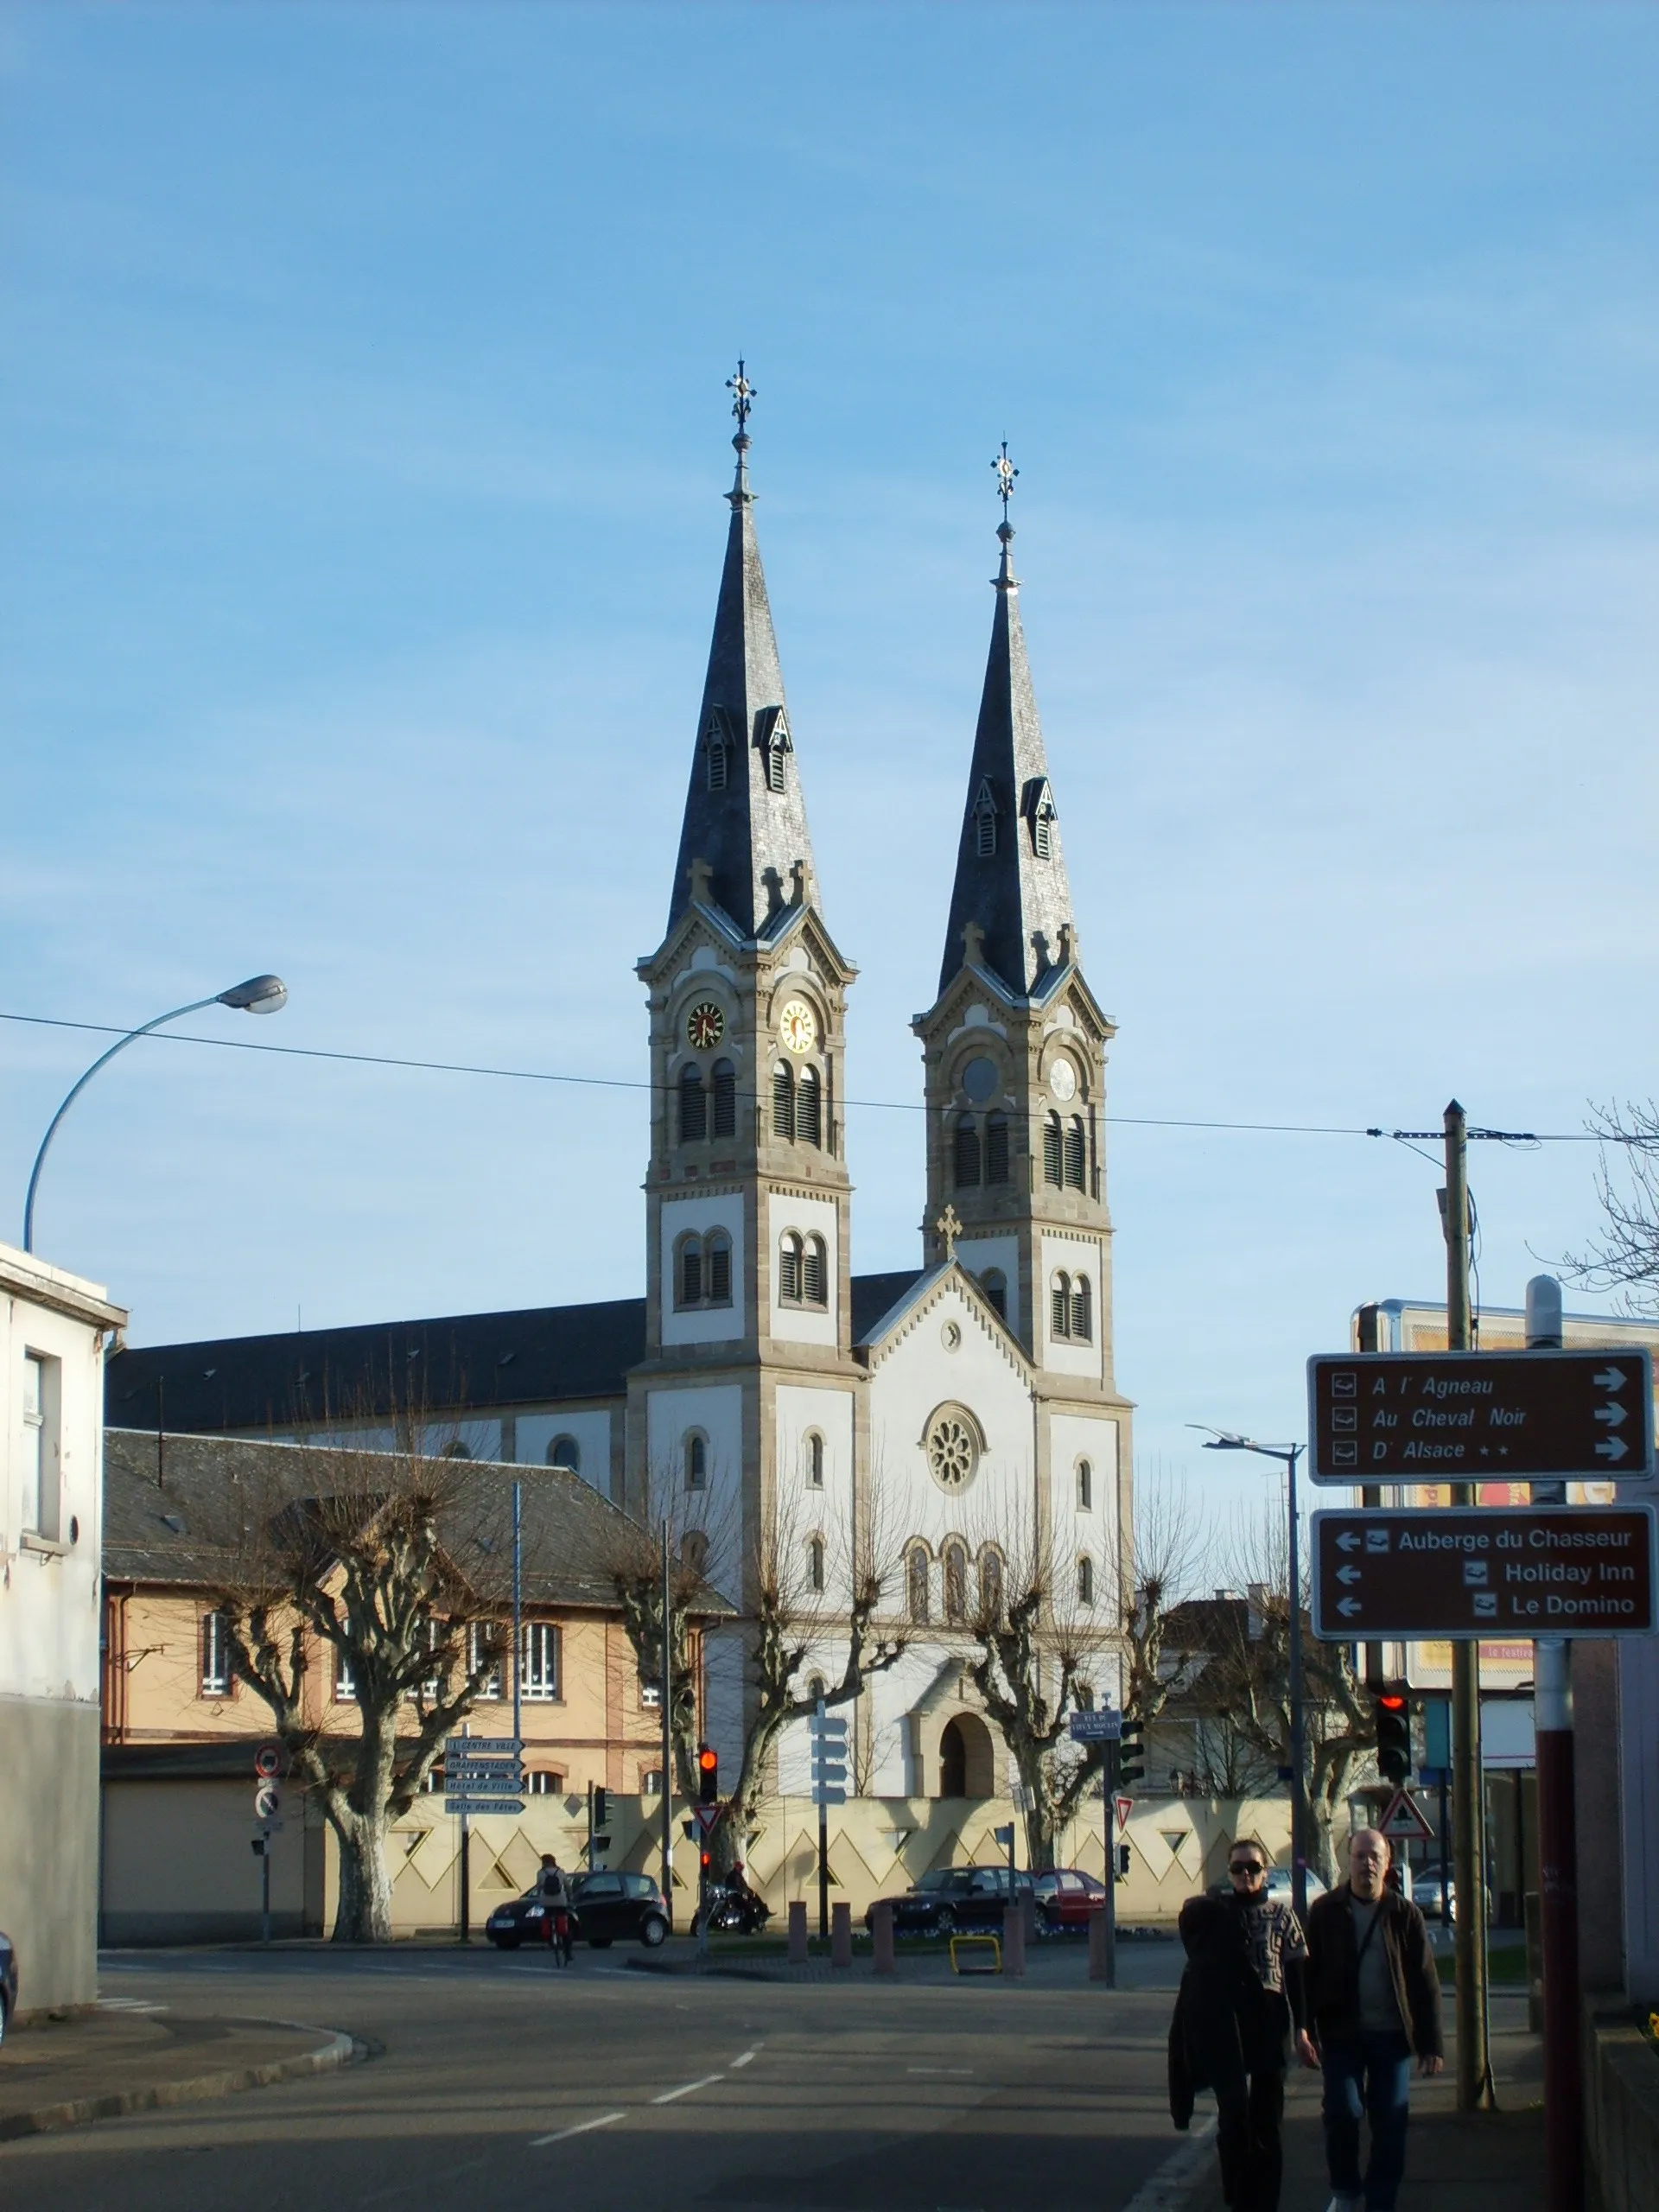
[1526,1274,1584,2212]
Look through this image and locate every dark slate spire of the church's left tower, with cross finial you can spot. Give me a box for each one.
[668,360,814,938]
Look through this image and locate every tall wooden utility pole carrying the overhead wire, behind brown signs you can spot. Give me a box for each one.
[1442,1099,1497,2113]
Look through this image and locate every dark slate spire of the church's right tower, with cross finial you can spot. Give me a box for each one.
[938,442,1077,998]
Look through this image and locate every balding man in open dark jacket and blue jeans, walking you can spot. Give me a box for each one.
[1307,1827,1445,2212]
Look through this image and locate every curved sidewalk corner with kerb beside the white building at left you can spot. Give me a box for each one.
[0,1999,356,2141]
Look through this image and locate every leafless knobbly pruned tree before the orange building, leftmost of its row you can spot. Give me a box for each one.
[204,1431,511,1942]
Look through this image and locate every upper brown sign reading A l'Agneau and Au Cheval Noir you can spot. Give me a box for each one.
[1307,1351,1652,1486]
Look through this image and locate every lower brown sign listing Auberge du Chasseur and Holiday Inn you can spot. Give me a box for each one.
[1314,1506,1655,1643]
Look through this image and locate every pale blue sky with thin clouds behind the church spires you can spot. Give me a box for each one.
[0,4,1659,1497]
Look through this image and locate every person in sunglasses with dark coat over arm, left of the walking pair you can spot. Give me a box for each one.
[1170,1838,1319,2212]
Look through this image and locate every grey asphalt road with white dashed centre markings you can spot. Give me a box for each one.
[0,1947,1184,2212]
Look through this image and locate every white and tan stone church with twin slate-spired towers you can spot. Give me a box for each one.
[106,365,1130,1798]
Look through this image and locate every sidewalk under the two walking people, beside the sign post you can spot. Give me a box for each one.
[1190,1991,1544,2212]
